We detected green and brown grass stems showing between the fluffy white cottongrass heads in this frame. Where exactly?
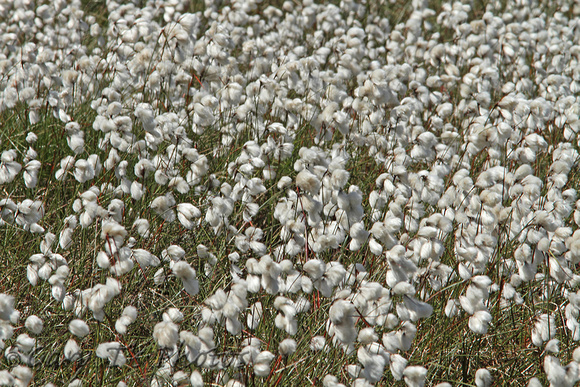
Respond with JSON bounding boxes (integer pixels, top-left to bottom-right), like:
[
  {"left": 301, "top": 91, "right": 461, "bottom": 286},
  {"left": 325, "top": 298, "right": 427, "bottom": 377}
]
[{"left": 0, "top": 1, "right": 580, "bottom": 386}]
